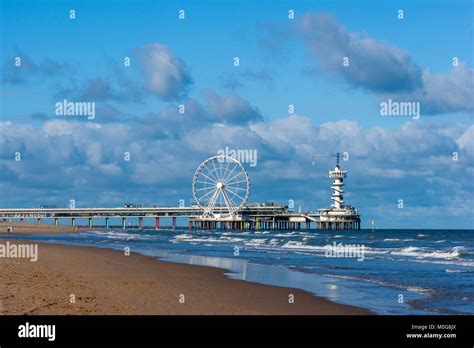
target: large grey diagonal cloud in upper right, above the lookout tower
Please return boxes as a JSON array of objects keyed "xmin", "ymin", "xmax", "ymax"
[{"xmin": 298, "ymin": 13, "xmax": 474, "ymax": 114}]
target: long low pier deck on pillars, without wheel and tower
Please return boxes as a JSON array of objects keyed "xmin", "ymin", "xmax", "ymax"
[{"xmin": 0, "ymin": 205, "xmax": 360, "ymax": 230}]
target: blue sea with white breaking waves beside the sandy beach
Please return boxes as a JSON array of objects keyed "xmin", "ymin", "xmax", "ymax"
[{"xmin": 4, "ymin": 229, "xmax": 474, "ymax": 315}]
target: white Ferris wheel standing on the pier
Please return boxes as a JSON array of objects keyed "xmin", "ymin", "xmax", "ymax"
[{"xmin": 193, "ymin": 156, "xmax": 250, "ymax": 218}]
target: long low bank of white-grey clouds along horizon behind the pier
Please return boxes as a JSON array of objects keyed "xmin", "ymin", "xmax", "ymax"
[{"xmin": 0, "ymin": 110, "xmax": 474, "ymax": 226}]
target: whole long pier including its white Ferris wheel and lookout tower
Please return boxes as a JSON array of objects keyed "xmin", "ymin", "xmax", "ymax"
[{"xmin": 0, "ymin": 153, "xmax": 360, "ymax": 230}]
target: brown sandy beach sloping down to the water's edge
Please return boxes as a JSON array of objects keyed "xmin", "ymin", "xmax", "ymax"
[{"xmin": 0, "ymin": 225, "xmax": 371, "ymax": 315}]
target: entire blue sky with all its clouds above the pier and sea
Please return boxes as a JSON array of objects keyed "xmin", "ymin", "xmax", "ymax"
[{"xmin": 0, "ymin": 0, "xmax": 474, "ymax": 228}]
